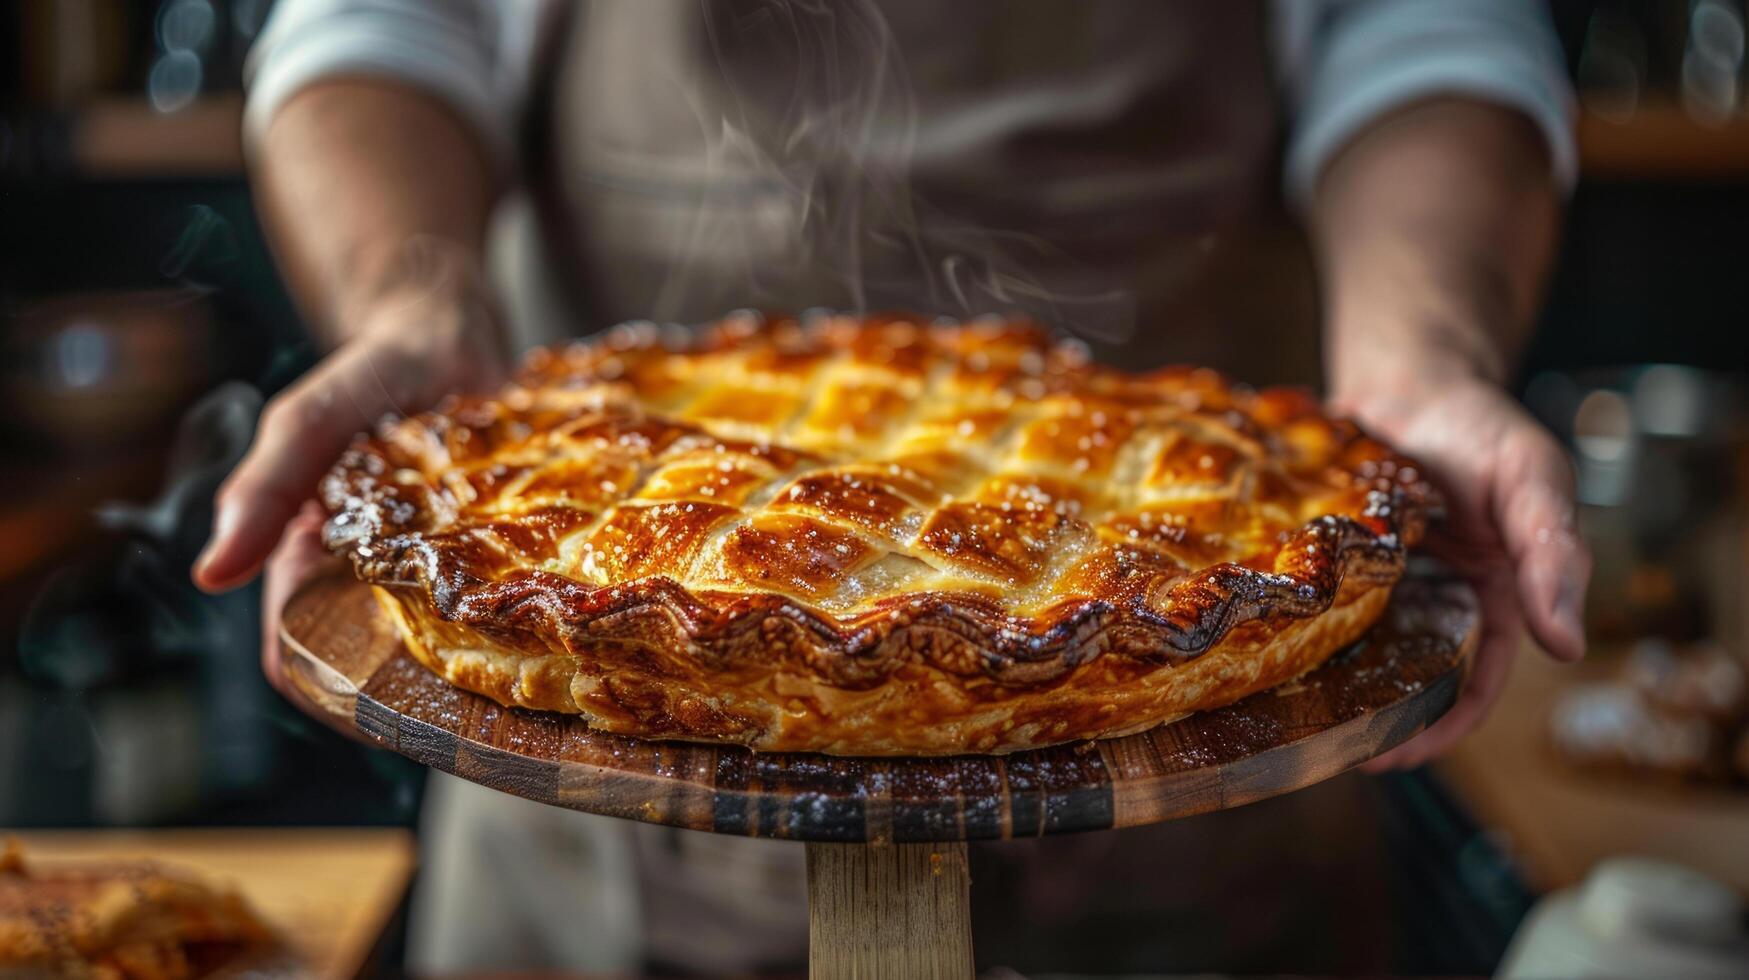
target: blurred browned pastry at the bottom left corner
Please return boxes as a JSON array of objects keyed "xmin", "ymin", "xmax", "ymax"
[{"xmin": 0, "ymin": 842, "xmax": 271, "ymax": 980}]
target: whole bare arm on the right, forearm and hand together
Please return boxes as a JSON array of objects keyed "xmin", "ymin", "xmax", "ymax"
[{"xmin": 1312, "ymin": 100, "xmax": 1590, "ymax": 767}]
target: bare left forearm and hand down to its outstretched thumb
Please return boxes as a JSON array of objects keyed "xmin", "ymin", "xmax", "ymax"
[{"xmin": 194, "ymin": 79, "xmax": 504, "ymax": 598}]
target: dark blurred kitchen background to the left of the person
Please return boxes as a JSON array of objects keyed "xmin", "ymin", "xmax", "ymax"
[{"xmin": 0, "ymin": 0, "xmax": 418, "ymax": 826}]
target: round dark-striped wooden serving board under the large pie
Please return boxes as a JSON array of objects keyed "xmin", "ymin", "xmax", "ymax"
[{"xmin": 282, "ymin": 572, "xmax": 1478, "ymax": 844}]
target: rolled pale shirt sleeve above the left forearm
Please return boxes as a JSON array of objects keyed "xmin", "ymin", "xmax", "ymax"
[{"xmin": 243, "ymin": 0, "xmax": 542, "ymax": 168}]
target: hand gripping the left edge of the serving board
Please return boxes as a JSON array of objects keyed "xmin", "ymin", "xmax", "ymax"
[{"xmin": 192, "ymin": 266, "xmax": 507, "ymax": 697}]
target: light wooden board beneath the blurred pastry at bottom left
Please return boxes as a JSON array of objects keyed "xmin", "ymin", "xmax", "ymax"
[{"xmin": 16, "ymin": 828, "xmax": 415, "ymax": 978}]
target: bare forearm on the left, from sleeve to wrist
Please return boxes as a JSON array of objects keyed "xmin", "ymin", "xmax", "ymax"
[{"xmin": 252, "ymin": 79, "xmax": 497, "ymax": 343}]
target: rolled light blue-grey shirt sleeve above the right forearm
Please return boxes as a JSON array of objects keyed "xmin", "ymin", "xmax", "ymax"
[{"xmin": 1273, "ymin": 0, "xmax": 1578, "ymax": 208}]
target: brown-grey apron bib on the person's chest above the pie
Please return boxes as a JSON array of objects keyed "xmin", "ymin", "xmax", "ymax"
[{"xmin": 530, "ymin": 0, "xmax": 1279, "ymax": 357}]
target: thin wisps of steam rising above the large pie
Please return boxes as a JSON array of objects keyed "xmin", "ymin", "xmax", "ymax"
[{"xmin": 656, "ymin": 0, "xmax": 1133, "ymax": 341}]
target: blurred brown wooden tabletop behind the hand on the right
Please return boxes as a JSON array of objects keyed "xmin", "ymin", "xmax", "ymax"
[{"xmin": 1438, "ymin": 649, "xmax": 1749, "ymax": 894}]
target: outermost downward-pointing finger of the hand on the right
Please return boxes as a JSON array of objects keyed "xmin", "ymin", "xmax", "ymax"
[{"xmin": 1492, "ymin": 418, "xmax": 1592, "ymax": 660}]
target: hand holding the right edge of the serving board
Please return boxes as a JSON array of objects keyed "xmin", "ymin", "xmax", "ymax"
[{"xmin": 1334, "ymin": 376, "xmax": 1592, "ymax": 772}]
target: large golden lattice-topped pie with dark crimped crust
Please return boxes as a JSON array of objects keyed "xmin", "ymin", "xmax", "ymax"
[{"xmin": 322, "ymin": 313, "xmax": 1431, "ymax": 756}]
